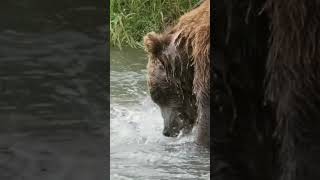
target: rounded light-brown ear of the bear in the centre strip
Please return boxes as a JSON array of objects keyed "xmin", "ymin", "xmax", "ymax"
[{"xmin": 143, "ymin": 32, "xmax": 163, "ymax": 57}]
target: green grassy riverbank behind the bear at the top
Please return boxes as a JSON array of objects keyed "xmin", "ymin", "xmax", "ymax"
[{"xmin": 110, "ymin": 0, "xmax": 199, "ymax": 48}]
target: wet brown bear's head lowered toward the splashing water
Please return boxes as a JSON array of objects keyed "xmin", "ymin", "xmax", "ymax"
[{"xmin": 144, "ymin": 32, "xmax": 197, "ymax": 137}]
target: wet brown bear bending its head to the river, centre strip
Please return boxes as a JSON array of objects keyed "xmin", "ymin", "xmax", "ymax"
[{"xmin": 144, "ymin": 0, "xmax": 210, "ymax": 146}]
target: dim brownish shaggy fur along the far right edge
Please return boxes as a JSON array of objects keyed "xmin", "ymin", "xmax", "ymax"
[{"xmin": 266, "ymin": 0, "xmax": 320, "ymax": 180}]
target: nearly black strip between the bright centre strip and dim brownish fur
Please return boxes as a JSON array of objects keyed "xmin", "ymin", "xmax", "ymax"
[{"xmin": 211, "ymin": 0, "xmax": 275, "ymax": 180}]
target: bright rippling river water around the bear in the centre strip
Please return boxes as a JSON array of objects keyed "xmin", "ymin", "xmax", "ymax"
[{"xmin": 110, "ymin": 49, "xmax": 210, "ymax": 180}]
